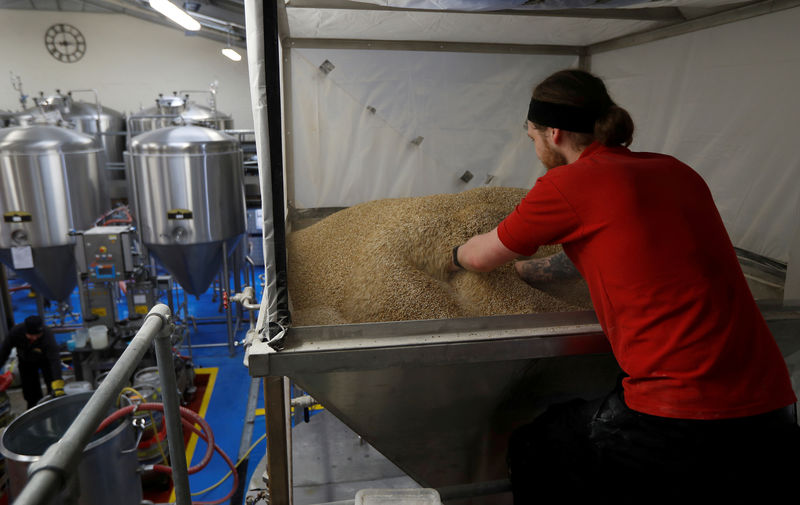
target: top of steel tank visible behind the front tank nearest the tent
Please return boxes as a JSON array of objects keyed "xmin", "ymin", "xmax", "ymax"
[{"xmin": 128, "ymin": 92, "xmax": 233, "ymax": 136}]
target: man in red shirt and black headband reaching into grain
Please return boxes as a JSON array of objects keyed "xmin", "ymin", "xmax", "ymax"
[{"xmin": 451, "ymin": 70, "xmax": 800, "ymax": 505}]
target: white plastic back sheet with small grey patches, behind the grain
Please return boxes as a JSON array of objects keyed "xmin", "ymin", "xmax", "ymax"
[{"xmin": 290, "ymin": 49, "xmax": 577, "ymax": 208}]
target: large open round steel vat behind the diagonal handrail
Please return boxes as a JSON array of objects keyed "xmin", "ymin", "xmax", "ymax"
[{"xmin": 0, "ymin": 393, "xmax": 142, "ymax": 505}]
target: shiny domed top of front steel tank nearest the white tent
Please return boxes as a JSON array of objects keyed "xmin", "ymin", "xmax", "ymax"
[{"xmin": 131, "ymin": 126, "xmax": 241, "ymax": 154}]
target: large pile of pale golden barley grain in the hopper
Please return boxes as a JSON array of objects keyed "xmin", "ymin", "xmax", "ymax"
[{"xmin": 287, "ymin": 188, "xmax": 591, "ymax": 326}]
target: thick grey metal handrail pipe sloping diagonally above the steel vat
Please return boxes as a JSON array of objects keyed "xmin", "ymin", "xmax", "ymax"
[{"xmin": 14, "ymin": 304, "xmax": 170, "ymax": 505}]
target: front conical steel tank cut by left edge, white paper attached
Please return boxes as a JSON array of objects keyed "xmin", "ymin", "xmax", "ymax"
[{"xmin": 0, "ymin": 126, "xmax": 108, "ymax": 301}]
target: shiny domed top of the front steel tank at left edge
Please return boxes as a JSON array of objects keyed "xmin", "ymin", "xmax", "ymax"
[{"xmin": 0, "ymin": 125, "xmax": 102, "ymax": 154}]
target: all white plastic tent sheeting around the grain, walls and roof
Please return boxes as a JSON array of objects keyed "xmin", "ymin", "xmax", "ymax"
[{"xmin": 287, "ymin": 0, "xmax": 800, "ymax": 261}]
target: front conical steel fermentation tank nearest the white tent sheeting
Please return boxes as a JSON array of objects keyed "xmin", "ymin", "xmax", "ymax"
[{"xmin": 127, "ymin": 126, "xmax": 245, "ymax": 295}]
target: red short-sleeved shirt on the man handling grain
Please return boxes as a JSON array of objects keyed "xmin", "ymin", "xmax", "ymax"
[{"xmin": 498, "ymin": 143, "xmax": 796, "ymax": 419}]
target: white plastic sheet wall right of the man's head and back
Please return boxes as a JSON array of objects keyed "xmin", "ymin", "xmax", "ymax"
[{"xmin": 592, "ymin": 9, "xmax": 800, "ymax": 261}]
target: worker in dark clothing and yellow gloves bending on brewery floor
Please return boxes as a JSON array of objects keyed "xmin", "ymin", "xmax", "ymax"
[{"xmin": 0, "ymin": 315, "xmax": 64, "ymax": 408}]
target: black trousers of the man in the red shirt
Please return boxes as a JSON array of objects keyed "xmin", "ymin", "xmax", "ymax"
[{"xmin": 508, "ymin": 387, "xmax": 800, "ymax": 505}]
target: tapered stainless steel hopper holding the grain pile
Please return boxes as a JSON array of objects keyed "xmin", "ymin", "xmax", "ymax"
[{"xmin": 246, "ymin": 305, "xmax": 800, "ymax": 504}]
